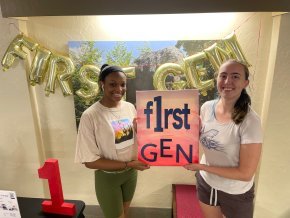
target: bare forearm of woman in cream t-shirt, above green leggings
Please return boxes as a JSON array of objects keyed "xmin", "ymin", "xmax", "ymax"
[{"xmin": 84, "ymin": 158, "xmax": 150, "ymax": 171}]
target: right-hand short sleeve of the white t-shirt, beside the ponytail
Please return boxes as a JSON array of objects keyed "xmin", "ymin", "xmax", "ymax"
[{"xmin": 240, "ymin": 111, "xmax": 263, "ymax": 144}]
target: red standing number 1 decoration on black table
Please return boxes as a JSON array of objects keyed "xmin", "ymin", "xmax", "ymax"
[{"xmin": 38, "ymin": 159, "xmax": 76, "ymax": 216}]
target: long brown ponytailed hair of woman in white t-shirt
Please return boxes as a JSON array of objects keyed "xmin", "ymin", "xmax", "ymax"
[{"xmin": 215, "ymin": 59, "xmax": 251, "ymax": 124}]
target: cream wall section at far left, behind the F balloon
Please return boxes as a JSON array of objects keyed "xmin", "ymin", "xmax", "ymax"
[{"xmin": 0, "ymin": 11, "xmax": 43, "ymax": 197}]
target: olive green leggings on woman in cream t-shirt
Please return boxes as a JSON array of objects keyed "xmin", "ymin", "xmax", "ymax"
[{"xmin": 95, "ymin": 169, "xmax": 137, "ymax": 218}]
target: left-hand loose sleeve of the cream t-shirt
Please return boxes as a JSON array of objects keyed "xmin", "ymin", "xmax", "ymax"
[{"xmin": 75, "ymin": 112, "xmax": 100, "ymax": 163}]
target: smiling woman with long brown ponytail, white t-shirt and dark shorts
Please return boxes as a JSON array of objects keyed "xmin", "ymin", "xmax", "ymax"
[{"xmin": 184, "ymin": 60, "xmax": 262, "ymax": 218}]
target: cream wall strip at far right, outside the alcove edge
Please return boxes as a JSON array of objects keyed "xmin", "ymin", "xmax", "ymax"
[{"xmin": 255, "ymin": 13, "xmax": 290, "ymax": 218}]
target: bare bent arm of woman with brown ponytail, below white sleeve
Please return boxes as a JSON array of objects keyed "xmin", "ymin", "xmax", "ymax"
[{"xmin": 184, "ymin": 143, "xmax": 262, "ymax": 181}]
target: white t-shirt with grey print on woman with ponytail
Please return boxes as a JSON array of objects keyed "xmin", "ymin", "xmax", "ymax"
[{"xmin": 200, "ymin": 100, "xmax": 263, "ymax": 194}]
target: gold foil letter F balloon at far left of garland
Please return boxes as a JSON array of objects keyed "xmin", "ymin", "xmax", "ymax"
[{"xmin": 1, "ymin": 34, "xmax": 38, "ymax": 71}]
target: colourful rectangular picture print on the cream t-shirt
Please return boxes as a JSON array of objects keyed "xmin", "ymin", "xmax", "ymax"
[{"xmin": 111, "ymin": 118, "xmax": 134, "ymax": 149}]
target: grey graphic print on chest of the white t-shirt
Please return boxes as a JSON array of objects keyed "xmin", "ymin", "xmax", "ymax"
[{"xmin": 200, "ymin": 127, "xmax": 224, "ymax": 152}]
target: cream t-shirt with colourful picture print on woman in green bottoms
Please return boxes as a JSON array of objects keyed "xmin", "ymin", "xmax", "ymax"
[{"xmin": 75, "ymin": 101, "xmax": 137, "ymax": 163}]
